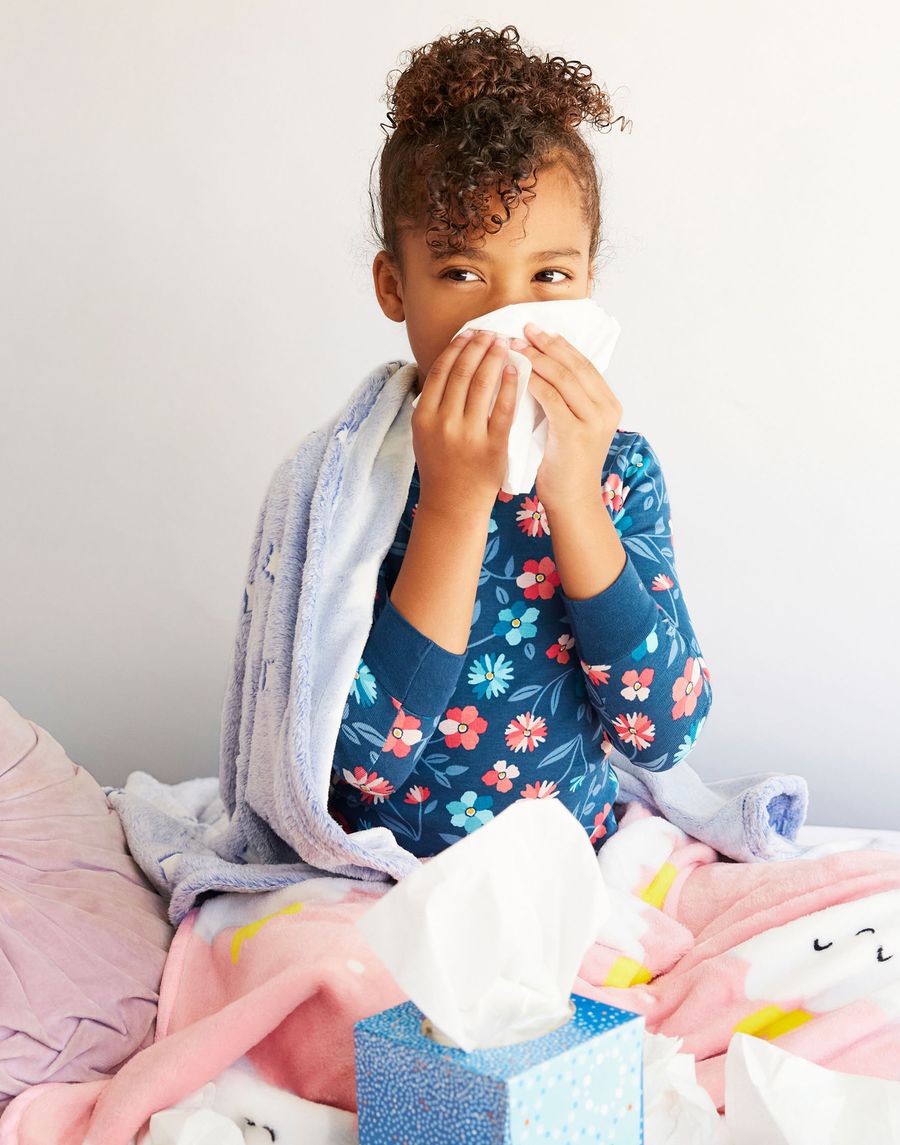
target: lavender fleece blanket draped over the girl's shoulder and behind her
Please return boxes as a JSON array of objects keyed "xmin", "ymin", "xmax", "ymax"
[{"xmin": 106, "ymin": 360, "xmax": 807, "ymax": 924}]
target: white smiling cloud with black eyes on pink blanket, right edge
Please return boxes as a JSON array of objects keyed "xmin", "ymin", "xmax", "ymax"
[{"xmin": 732, "ymin": 891, "xmax": 900, "ymax": 1037}]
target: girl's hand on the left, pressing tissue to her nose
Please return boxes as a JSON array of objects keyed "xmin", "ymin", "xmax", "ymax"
[{"xmin": 412, "ymin": 331, "xmax": 518, "ymax": 515}]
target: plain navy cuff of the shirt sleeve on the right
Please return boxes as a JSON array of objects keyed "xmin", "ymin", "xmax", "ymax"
[{"xmin": 560, "ymin": 553, "xmax": 660, "ymax": 664}]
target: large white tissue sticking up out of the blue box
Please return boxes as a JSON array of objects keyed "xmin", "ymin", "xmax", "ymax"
[{"xmin": 357, "ymin": 799, "xmax": 608, "ymax": 1051}]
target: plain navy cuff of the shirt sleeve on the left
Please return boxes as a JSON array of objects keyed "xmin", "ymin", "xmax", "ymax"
[{"xmin": 363, "ymin": 597, "xmax": 468, "ymax": 716}]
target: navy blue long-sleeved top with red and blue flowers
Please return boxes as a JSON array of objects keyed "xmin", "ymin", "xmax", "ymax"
[{"xmin": 329, "ymin": 429, "xmax": 712, "ymax": 856}]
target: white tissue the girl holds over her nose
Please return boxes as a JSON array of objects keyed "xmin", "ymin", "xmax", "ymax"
[{"xmin": 412, "ymin": 298, "xmax": 622, "ymax": 496}]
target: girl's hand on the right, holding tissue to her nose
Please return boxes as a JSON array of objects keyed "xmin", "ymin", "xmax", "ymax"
[{"xmin": 512, "ymin": 322, "xmax": 622, "ymax": 514}]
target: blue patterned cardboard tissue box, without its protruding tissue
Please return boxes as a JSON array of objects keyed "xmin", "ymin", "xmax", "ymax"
[{"xmin": 354, "ymin": 994, "xmax": 644, "ymax": 1145}]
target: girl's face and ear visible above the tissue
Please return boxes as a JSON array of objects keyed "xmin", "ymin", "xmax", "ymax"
[{"xmin": 372, "ymin": 165, "xmax": 593, "ymax": 393}]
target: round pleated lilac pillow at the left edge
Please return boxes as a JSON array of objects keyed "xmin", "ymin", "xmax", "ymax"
[{"xmin": 0, "ymin": 696, "xmax": 173, "ymax": 1111}]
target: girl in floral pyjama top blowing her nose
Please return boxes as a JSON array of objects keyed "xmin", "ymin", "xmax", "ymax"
[{"xmin": 329, "ymin": 25, "xmax": 711, "ymax": 856}]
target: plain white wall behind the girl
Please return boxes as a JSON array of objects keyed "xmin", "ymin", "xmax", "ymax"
[{"xmin": 0, "ymin": 0, "xmax": 900, "ymax": 827}]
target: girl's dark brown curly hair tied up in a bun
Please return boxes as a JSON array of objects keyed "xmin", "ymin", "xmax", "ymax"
[{"xmin": 369, "ymin": 24, "xmax": 631, "ymax": 275}]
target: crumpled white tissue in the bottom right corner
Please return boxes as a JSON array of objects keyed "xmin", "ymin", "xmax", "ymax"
[{"xmin": 725, "ymin": 1034, "xmax": 900, "ymax": 1145}]
